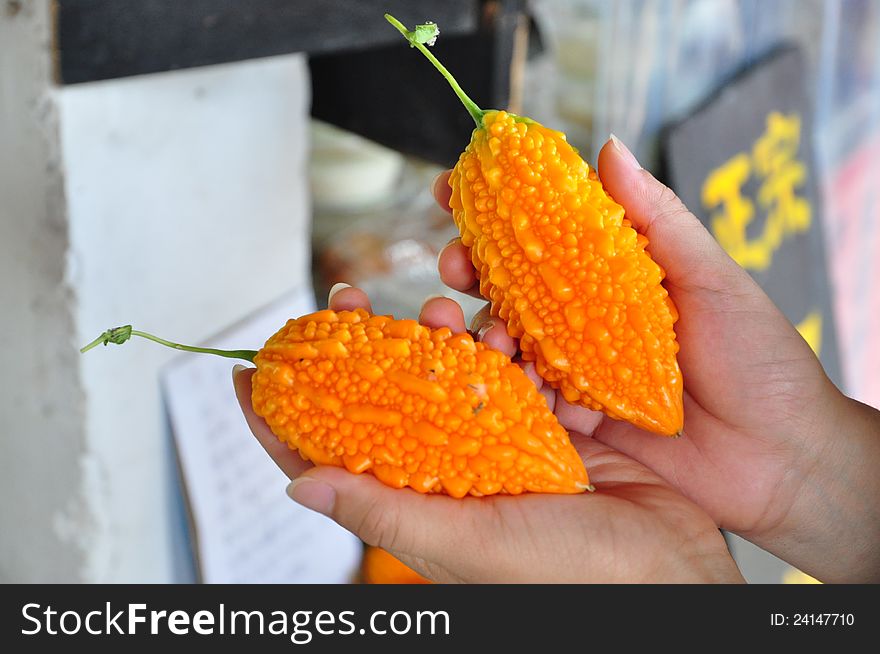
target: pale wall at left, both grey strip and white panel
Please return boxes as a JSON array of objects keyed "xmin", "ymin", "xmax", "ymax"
[{"xmin": 0, "ymin": 3, "xmax": 309, "ymax": 582}]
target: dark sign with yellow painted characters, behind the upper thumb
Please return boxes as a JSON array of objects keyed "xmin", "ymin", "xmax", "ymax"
[{"xmin": 664, "ymin": 48, "xmax": 841, "ymax": 383}]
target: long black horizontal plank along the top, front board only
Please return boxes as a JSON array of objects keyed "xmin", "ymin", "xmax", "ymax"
[{"xmin": 55, "ymin": 0, "xmax": 481, "ymax": 84}]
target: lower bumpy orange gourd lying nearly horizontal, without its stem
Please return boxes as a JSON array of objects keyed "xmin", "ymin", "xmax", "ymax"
[{"xmin": 252, "ymin": 309, "xmax": 589, "ymax": 497}]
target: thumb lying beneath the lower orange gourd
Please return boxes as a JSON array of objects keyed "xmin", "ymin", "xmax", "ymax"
[{"xmin": 287, "ymin": 466, "xmax": 464, "ymax": 579}]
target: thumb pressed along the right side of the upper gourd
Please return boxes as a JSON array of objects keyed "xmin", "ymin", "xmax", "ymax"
[{"xmin": 599, "ymin": 136, "xmax": 755, "ymax": 294}]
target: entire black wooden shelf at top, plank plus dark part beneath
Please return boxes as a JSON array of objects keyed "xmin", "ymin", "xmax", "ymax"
[{"xmin": 54, "ymin": 0, "xmax": 524, "ymax": 164}]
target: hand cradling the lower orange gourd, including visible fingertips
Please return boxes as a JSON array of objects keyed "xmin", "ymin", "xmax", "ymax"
[{"xmin": 233, "ymin": 287, "xmax": 742, "ymax": 583}]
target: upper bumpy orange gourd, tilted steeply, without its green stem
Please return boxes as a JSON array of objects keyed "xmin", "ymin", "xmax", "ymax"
[{"xmin": 450, "ymin": 111, "xmax": 683, "ymax": 435}]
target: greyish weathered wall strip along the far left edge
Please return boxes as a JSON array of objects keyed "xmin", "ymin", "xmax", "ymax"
[{"xmin": 0, "ymin": 2, "xmax": 94, "ymax": 581}]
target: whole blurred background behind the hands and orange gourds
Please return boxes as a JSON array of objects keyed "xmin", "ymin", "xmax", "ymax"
[{"xmin": 0, "ymin": 0, "xmax": 880, "ymax": 583}]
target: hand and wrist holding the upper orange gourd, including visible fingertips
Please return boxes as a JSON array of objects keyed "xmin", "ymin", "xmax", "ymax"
[{"xmin": 434, "ymin": 137, "xmax": 880, "ymax": 582}]
